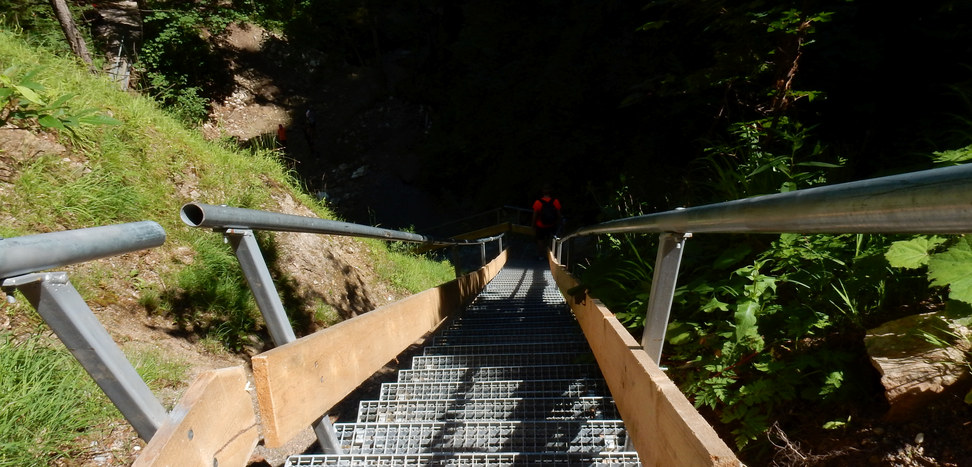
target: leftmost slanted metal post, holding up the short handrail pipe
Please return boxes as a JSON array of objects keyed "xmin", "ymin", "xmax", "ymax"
[{"xmin": 3, "ymin": 272, "xmax": 168, "ymax": 441}]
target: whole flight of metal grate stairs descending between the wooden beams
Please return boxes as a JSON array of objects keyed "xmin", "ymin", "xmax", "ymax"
[{"xmin": 286, "ymin": 262, "xmax": 641, "ymax": 466}]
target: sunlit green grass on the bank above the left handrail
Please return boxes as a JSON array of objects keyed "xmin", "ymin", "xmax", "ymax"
[{"xmin": 0, "ymin": 27, "xmax": 312, "ymax": 241}]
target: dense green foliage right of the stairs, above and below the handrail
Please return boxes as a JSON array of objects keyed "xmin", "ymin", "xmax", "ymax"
[{"xmin": 568, "ymin": 1, "xmax": 972, "ymax": 460}]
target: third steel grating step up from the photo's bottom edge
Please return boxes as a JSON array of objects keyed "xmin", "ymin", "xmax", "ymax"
[{"xmin": 357, "ymin": 397, "xmax": 620, "ymax": 423}]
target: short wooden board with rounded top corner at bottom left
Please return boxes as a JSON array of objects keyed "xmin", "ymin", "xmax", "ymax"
[{"xmin": 132, "ymin": 367, "xmax": 259, "ymax": 467}]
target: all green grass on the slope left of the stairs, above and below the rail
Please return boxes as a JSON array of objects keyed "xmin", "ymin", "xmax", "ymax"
[{"xmin": 0, "ymin": 25, "xmax": 453, "ymax": 466}]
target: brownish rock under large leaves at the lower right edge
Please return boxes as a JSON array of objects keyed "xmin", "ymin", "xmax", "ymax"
[{"xmin": 864, "ymin": 313, "xmax": 970, "ymax": 421}]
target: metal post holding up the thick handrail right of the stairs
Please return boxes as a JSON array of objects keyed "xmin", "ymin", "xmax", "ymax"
[{"xmin": 641, "ymin": 233, "xmax": 692, "ymax": 363}]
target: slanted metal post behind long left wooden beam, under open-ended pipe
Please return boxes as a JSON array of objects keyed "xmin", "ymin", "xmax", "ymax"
[{"xmin": 224, "ymin": 229, "xmax": 343, "ymax": 454}]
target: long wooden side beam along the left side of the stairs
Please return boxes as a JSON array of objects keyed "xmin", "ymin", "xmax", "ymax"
[{"xmin": 251, "ymin": 252, "xmax": 507, "ymax": 448}]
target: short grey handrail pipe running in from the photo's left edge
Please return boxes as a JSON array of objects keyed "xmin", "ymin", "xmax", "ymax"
[{"xmin": 0, "ymin": 221, "xmax": 165, "ymax": 279}]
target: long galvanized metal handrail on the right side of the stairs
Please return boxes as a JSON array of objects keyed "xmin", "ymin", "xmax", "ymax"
[{"xmin": 563, "ymin": 164, "xmax": 972, "ymax": 240}]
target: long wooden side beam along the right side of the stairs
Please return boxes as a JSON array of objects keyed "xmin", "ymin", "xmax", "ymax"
[{"xmin": 549, "ymin": 256, "xmax": 741, "ymax": 466}]
